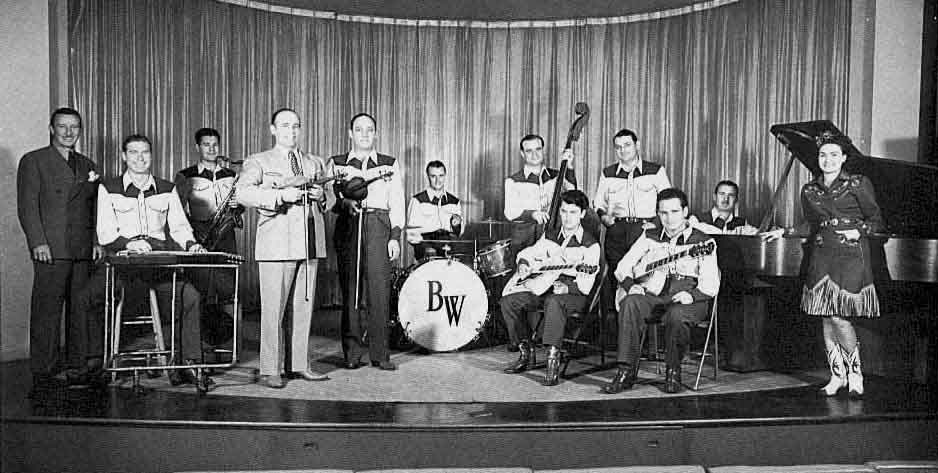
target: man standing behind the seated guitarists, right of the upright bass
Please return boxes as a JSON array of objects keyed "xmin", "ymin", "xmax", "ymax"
[{"xmin": 593, "ymin": 129, "xmax": 671, "ymax": 267}]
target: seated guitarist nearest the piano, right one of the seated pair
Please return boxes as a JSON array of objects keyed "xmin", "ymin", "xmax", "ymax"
[{"xmin": 603, "ymin": 188, "xmax": 720, "ymax": 394}]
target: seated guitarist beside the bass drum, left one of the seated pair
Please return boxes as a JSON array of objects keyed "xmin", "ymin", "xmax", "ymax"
[{"xmin": 499, "ymin": 190, "xmax": 600, "ymax": 386}]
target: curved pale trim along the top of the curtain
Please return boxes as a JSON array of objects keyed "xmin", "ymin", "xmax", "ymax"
[{"xmin": 216, "ymin": 0, "xmax": 739, "ymax": 29}]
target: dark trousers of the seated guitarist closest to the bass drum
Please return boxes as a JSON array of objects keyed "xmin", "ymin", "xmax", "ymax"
[{"xmin": 498, "ymin": 292, "xmax": 587, "ymax": 347}]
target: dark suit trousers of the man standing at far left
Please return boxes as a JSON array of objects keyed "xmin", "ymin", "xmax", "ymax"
[{"xmin": 29, "ymin": 259, "xmax": 91, "ymax": 375}]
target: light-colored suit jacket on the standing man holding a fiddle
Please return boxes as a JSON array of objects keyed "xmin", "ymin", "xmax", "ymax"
[{"xmin": 235, "ymin": 148, "xmax": 334, "ymax": 261}]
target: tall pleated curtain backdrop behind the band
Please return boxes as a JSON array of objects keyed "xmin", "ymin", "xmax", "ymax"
[{"xmin": 69, "ymin": 0, "xmax": 850, "ymax": 306}]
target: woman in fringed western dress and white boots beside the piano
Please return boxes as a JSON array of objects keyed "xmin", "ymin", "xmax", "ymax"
[{"xmin": 767, "ymin": 132, "xmax": 883, "ymax": 396}]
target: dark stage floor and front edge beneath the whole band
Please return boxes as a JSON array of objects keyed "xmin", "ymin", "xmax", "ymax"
[{"xmin": 2, "ymin": 312, "xmax": 938, "ymax": 472}]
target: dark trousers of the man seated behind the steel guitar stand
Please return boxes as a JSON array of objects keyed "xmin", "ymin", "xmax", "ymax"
[{"xmin": 76, "ymin": 267, "xmax": 202, "ymax": 362}]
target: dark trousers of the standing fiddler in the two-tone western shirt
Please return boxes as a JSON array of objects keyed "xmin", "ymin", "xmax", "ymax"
[{"xmin": 335, "ymin": 212, "xmax": 391, "ymax": 362}]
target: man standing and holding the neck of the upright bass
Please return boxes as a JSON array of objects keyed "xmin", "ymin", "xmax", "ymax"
[{"xmin": 505, "ymin": 135, "xmax": 576, "ymax": 254}]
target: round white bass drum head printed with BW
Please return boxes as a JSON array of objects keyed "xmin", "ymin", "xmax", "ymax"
[{"xmin": 397, "ymin": 259, "xmax": 488, "ymax": 351}]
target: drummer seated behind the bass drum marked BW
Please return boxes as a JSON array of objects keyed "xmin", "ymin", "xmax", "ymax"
[{"xmin": 407, "ymin": 161, "xmax": 462, "ymax": 260}]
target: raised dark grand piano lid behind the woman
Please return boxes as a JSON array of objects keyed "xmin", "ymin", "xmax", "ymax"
[{"xmin": 769, "ymin": 120, "xmax": 938, "ymax": 238}]
